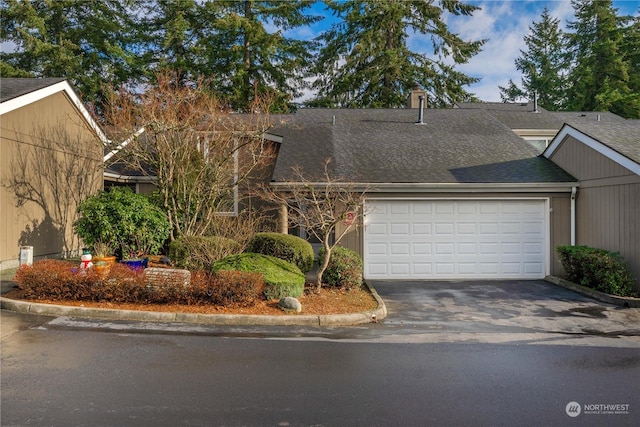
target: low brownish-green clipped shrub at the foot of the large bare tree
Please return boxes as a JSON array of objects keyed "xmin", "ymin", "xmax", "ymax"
[{"xmin": 169, "ymin": 236, "xmax": 241, "ymax": 270}]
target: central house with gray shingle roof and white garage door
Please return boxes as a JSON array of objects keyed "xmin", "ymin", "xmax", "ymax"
[{"xmin": 270, "ymin": 98, "xmax": 579, "ymax": 279}]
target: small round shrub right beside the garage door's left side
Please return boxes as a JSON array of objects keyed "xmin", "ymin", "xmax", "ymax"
[{"xmin": 319, "ymin": 246, "xmax": 362, "ymax": 289}]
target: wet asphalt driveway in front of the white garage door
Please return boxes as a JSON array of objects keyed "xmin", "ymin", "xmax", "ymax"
[{"xmin": 370, "ymin": 280, "xmax": 640, "ymax": 339}]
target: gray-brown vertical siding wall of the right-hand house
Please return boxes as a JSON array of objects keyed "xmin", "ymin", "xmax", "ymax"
[{"xmin": 551, "ymin": 136, "xmax": 640, "ymax": 288}]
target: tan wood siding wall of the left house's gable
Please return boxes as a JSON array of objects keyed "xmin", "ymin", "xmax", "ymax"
[{"xmin": 0, "ymin": 92, "xmax": 102, "ymax": 268}]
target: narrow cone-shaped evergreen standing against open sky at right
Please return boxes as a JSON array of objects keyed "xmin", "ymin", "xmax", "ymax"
[{"xmin": 500, "ymin": 7, "xmax": 566, "ymax": 111}]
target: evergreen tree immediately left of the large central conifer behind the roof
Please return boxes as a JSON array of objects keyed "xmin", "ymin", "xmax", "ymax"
[{"xmin": 206, "ymin": 0, "xmax": 320, "ymax": 112}]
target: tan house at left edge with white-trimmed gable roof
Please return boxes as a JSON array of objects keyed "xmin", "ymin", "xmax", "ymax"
[{"xmin": 0, "ymin": 78, "xmax": 106, "ymax": 269}]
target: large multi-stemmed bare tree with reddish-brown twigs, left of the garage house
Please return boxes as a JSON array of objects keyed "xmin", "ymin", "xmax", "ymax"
[{"xmin": 105, "ymin": 72, "xmax": 271, "ymax": 240}]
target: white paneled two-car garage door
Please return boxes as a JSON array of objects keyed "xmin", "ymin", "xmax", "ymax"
[{"xmin": 364, "ymin": 200, "xmax": 548, "ymax": 279}]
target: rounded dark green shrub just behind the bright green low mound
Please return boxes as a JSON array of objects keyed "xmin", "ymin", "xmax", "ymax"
[{"xmin": 246, "ymin": 233, "xmax": 314, "ymax": 273}]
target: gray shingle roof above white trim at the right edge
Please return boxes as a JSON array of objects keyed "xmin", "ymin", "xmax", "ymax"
[{"xmin": 570, "ymin": 122, "xmax": 640, "ymax": 164}]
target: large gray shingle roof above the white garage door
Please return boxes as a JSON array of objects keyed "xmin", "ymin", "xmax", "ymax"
[{"xmin": 270, "ymin": 109, "xmax": 575, "ymax": 183}]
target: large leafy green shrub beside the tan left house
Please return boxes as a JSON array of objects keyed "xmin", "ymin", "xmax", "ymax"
[{"xmin": 73, "ymin": 187, "xmax": 171, "ymax": 257}]
